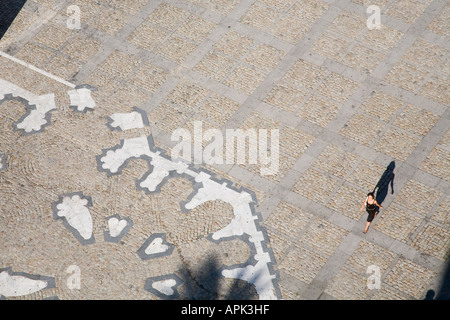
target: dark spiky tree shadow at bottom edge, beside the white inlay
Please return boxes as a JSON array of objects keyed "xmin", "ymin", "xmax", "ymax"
[{"xmin": 179, "ymin": 255, "xmax": 259, "ymax": 300}]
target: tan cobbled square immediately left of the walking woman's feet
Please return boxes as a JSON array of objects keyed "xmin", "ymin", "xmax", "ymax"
[{"xmin": 298, "ymin": 218, "xmax": 348, "ymax": 256}]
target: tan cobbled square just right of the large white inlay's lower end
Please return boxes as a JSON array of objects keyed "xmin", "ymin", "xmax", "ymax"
[{"xmin": 279, "ymin": 245, "xmax": 327, "ymax": 284}]
